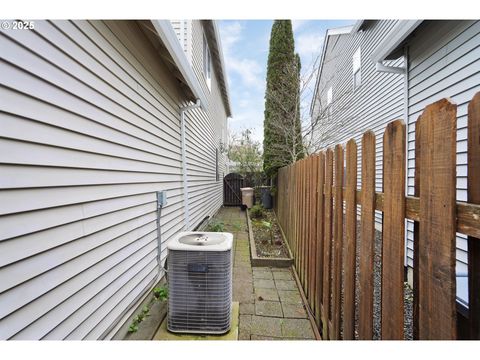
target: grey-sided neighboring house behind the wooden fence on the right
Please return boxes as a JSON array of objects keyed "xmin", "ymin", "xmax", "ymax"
[{"xmin": 311, "ymin": 20, "xmax": 480, "ymax": 305}]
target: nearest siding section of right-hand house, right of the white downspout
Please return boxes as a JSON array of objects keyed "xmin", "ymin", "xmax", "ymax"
[{"xmin": 407, "ymin": 21, "xmax": 480, "ymax": 273}]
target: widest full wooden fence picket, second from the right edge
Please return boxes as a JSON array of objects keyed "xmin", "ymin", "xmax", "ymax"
[{"xmin": 414, "ymin": 99, "xmax": 457, "ymax": 340}]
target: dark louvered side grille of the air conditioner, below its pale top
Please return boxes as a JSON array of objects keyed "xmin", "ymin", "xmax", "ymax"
[{"xmin": 168, "ymin": 250, "xmax": 232, "ymax": 333}]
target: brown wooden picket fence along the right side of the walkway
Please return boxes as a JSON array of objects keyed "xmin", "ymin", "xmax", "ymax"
[{"xmin": 276, "ymin": 93, "xmax": 480, "ymax": 339}]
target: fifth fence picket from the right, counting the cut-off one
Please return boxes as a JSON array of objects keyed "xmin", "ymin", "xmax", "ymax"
[{"xmin": 343, "ymin": 139, "xmax": 357, "ymax": 340}]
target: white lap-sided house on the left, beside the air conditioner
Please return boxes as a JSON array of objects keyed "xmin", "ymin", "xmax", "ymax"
[{"xmin": 0, "ymin": 21, "xmax": 230, "ymax": 339}]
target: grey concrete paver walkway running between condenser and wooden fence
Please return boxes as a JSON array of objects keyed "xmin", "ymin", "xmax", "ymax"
[{"xmin": 216, "ymin": 208, "xmax": 315, "ymax": 340}]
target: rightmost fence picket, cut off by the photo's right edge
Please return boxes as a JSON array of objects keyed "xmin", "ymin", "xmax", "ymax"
[{"xmin": 467, "ymin": 92, "xmax": 480, "ymax": 339}]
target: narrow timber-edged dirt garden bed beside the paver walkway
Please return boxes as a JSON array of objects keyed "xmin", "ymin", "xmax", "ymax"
[{"xmin": 247, "ymin": 208, "xmax": 293, "ymax": 267}]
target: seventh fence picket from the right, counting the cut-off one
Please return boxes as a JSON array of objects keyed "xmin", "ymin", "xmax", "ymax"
[{"xmin": 322, "ymin": 149, "xmax": 333, "ymax": 340}]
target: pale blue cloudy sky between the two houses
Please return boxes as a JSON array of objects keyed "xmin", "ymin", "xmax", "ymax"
[{"xmin": 218, "ymin": 20, "xmax": 354, "ymax": 142}]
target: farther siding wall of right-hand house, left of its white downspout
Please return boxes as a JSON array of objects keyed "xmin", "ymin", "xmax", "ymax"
[{"xmin": 312, "ymin": 20, "xmax": 404, "ymax": 228}]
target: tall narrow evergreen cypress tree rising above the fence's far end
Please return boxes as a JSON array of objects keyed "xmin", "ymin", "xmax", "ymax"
[{"xmin": 263, "ymin": 20, "xmax": 303, "ymax": 177}]
